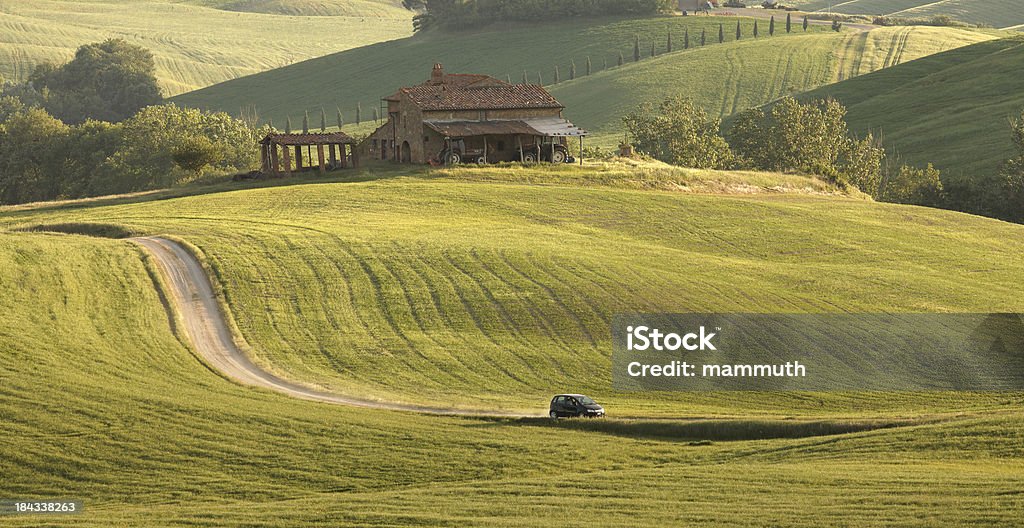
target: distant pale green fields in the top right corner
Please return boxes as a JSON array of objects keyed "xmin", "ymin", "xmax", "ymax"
[{"xmin": 787, "ymin": 0, "xmax": 1024, "ymax": 28}]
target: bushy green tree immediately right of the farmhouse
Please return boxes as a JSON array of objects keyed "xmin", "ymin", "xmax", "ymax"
[{"xmin": 623, "ymin": 97, "xmax": 732, "ymax": 169}]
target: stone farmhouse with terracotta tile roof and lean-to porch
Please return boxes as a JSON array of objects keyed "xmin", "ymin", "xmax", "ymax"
[{"xmin": 358, "ymin": 64, "xmax": 587, "ymax": 164}]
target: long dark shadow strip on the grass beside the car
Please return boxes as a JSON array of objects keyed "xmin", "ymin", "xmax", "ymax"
[{"xmin": 477, "ymin": 419, "xmax": 923, "ymax": 445}]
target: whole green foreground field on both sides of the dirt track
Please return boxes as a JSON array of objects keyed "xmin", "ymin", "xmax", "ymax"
[{"xmin": 0, "ymin": 165, "xmax": 1024, "ymax": 527}]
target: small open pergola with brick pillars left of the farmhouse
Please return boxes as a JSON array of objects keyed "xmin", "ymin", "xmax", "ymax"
[{"xmin": 260, "ymin": 132, "xmax": 356, "ymax": 176}]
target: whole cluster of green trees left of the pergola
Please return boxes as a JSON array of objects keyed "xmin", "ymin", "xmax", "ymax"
[{"xmin": 0, "ymin": 40, "xmax": 269, "ymax": 204}]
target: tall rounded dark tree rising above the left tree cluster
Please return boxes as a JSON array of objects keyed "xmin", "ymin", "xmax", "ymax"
[{"xmin": 29, "ymin": 39, "xmax": 162, "ymax": 124}]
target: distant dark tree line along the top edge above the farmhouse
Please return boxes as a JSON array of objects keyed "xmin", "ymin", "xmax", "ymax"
[{"xmin": 402, "ymin": 0, "xmax": 676, "ymax": 31}]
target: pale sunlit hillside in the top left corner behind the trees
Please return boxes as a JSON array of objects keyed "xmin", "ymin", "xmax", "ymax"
[{"xmin": 0, "ymin": 0, "xmax": 413, "ymax": 96}]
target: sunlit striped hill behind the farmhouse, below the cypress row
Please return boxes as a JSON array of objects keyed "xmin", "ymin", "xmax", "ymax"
[{"xmin": 552, "ymin": 28, "xmax": 992, "ymax": 142}]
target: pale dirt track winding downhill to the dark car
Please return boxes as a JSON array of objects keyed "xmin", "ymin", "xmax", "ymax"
[{"xmin": 130, "ymin": 236, "xmax": 544, "ymax": 417}]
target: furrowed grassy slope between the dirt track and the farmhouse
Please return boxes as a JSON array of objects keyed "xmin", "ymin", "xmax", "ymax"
[{"xmin": 4, "ymin": 160, "xmax": 1024, "ymax": 415}]
